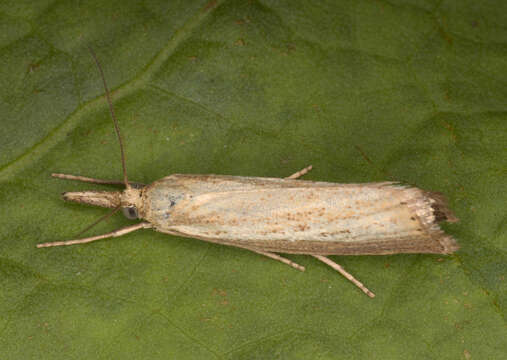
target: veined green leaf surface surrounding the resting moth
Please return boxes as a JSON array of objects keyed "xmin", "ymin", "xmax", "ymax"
[{"xmin": 0, "ymin": 0, "xmax": 507, "ymax": 359}]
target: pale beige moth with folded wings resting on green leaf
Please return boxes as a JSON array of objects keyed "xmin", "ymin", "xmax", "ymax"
[{"xmin": 37, "ymin": 49, "xmax": 459, "ymax": 297}]
